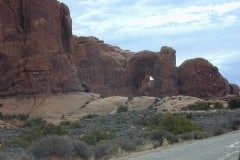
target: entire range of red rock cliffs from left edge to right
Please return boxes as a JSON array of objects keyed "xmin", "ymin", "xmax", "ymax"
[{"xmin": 0, "ymin": 0, "xmax": 239, "ymax": 97}]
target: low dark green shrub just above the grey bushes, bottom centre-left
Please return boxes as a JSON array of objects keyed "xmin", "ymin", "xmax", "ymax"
[{"xmin": 80, "ymin": 131, "xmax": 115, "ymax": 145}]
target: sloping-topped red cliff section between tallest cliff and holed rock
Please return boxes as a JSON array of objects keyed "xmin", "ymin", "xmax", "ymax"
[{"xmin": 72, "ymin": 37, "xmax": 131, "ymax": 96}]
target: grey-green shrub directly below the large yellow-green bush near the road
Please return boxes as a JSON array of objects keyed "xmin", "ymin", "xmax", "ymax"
[{"xmin": 147, "ymin": 129, "xmax": 178, "ymax": 144}]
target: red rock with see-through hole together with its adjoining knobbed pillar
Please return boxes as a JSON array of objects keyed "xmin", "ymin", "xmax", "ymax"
[{"xmin": 124, "ymin": 46, "xmax": 178, "ymax": 97}]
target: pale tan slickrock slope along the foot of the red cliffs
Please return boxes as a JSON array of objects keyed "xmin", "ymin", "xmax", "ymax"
[{"xmin": 0, "ymin": 92, "xmax": 224, "ymax": 126}]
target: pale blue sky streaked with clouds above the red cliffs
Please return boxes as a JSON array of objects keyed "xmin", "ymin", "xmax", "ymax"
[{"xmin": 60, "ymin": 0, "xmax": 240, "ymax": 85}]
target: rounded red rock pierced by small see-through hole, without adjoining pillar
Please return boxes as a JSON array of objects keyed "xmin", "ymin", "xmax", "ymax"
[{"xmin": 126, "ymin": 51, "xmax": 161, "ymax": 96}]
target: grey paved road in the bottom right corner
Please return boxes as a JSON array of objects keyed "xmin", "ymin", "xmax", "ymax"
[{"xmin": 118, "ymin": 131, "xmax": 240, "ymax": 160}]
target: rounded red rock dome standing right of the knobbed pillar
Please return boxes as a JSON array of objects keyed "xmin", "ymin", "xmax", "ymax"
[{"xmin": 178, "ymin": 58, "xmax": 228, "ymax": 97}]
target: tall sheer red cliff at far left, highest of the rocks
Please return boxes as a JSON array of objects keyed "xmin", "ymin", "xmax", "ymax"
[{"xmin": 0, "ymin": 0, "xmax": 83, "ymax": 96}]
